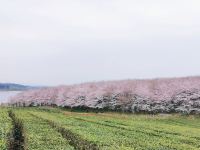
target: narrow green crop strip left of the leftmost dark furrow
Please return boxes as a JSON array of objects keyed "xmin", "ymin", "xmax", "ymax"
[{"xmin": 0, "ymin": 108, "xmax": 12, "ymax": 150}]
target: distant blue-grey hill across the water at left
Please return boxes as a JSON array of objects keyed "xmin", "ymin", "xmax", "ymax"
[{"xmin": 0, "ymin": 83, "xmax": 34, "ymax": 91}]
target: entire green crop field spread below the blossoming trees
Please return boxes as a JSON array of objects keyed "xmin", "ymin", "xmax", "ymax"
[{"xmin": 0, "ymin": 107, "xmax": 200, "ymax": 150}]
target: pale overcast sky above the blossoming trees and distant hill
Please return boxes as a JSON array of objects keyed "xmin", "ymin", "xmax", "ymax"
[{"xmin": 0, "ymin": 0, "xmax": 200, "ymax": 85}]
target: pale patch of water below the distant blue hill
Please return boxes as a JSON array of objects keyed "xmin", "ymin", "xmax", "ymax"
[{"xmin": 0, "ymin": 91, "xmax": 21, "ymax": 104}]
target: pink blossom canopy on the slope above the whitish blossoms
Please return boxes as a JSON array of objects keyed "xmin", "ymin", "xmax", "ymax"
[{"xmin": 10, "ymin": 77, "xmax": 200, "ymax": 105}]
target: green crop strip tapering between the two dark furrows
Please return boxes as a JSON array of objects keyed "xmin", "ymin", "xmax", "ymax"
[{"xmin": 14, "ymin": 110, "xmax": 73, "ymax": 150}]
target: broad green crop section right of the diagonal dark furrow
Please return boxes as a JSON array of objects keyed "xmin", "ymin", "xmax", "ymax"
[{"xmin": 30, "ymin": 110, "xmax": 200, "ymax": 150}]
